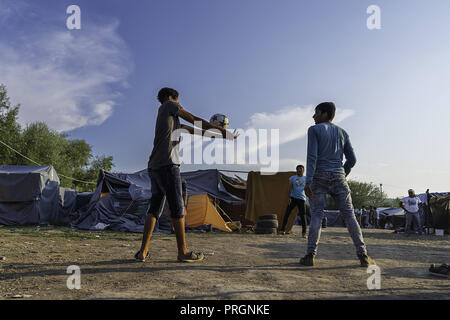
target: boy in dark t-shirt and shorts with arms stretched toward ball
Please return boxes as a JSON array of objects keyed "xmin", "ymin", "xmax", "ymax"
[{"xmin": 135, "ymin": 88, "xmax": 238, "ymax": 262}]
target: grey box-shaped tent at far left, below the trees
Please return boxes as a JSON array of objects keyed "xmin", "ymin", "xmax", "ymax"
[{"xmin": 0, "ymin": 166, "xmax": 62, "ymax": 225}]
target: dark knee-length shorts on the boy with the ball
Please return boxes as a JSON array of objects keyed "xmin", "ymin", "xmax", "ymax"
[{"xmin": 147, "ymin": 165, "xmax": 184, "ymax": 219}]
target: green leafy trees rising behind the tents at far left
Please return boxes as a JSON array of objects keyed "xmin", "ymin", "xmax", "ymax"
[{"xmin": 0, "ymin": 85, "xmax": 114, "ymax": 191}]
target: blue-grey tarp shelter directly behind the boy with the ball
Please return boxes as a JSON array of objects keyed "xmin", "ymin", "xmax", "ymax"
[{"xmin": 72, "ymin": 169, "xmax": 244, "ymax": 233}]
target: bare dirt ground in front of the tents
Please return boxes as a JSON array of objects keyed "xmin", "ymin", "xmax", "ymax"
[{"xmin": 0, "ymin": 226, "xmax": 450, "ymax": 300}]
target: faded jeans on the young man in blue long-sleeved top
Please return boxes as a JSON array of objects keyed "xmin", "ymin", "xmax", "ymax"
[{"xmin": 307, "ymin": 171, "xmax": 367, "ymax": 255}]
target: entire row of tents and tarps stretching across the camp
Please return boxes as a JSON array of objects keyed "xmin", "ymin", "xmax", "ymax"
[{"xmin": 0, "ymin": 166, "xmax": 450, "ymax": 232}]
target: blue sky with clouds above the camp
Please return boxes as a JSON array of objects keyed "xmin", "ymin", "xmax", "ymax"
[{"xmin": 0, "ymin": 0, "xmax": 450, "ymax": 197}]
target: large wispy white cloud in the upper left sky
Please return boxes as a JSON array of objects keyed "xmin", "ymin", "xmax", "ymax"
[{"xmin": 0, "ymin": 15, "xmax": 132, "ymax": 131}]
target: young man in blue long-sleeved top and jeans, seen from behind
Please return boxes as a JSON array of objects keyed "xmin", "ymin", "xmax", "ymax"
[{"xmin": 300, "ymin": 102, "xmax": 375, "ymax": 267}]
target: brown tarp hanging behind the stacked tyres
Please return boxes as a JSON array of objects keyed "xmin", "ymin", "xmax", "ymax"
[{"xmin": 245, "ymin": 171, "xmax": 298, "ymax": 231}]
